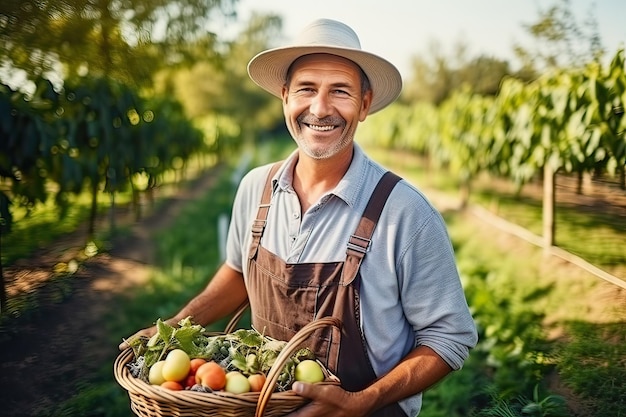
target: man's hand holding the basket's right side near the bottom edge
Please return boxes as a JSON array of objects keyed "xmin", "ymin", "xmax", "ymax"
[{"xmin": 287, "ymin": 382, "xmax": 373, "ymax": 417}]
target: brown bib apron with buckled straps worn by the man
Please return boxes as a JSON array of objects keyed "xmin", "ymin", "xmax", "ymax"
[{"xmin": 243, "ymin": 163, "xmax": 406, "ymax": 417}]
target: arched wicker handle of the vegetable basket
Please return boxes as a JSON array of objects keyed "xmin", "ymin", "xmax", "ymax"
[{"xmin": 255, "ymin": 316, "xmax": 341, "ymax": 417}]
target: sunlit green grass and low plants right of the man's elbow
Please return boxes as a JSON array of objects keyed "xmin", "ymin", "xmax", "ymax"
[{"xmin": 414, "ymin": 213, "xmax": 626, "ymax": 417}]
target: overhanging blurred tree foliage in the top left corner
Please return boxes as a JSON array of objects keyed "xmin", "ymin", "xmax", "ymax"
[{"xmin": 0, "ymin": 0, "xmax": 237, "ymax": 86}]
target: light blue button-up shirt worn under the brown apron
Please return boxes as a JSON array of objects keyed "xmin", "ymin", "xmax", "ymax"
[{"xmin": 226, "ymin": 143, "xmax": 477, "ymax": 416}]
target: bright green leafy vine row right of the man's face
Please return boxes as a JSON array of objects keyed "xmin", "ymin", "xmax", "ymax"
[{"xmin": 363, "ymin": 50, "xmax": 626, "ymax": 196}]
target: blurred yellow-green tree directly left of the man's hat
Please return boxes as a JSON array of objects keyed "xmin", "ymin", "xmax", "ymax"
[{"xmin": 155, "ymin": 14, "xmax": 282, "ymax": 152}]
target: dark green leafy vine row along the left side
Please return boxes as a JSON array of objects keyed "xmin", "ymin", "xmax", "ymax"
[{"xmin": 0, "ymin": 78, "xmax": 205, "ymax": 309}]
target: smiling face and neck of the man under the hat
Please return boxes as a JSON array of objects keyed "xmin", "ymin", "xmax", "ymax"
[{"xmin": 281, "ymin": 54, "xmax": 372, "ymax": 212}]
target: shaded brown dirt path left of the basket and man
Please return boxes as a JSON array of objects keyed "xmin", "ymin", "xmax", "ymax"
[{"xmin": 0, "ymin": 167, "xmax": 223, "ymax": 417}]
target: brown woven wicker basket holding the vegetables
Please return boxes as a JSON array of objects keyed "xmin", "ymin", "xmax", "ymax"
[{"xmin": 113, "ymin": 317, "xmax": 340, "ymax": 417}]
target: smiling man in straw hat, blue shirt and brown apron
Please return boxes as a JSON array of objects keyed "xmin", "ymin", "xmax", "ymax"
[{"xmin": 120, "ymin": 19, "xmax": 477, "ymax": 417}]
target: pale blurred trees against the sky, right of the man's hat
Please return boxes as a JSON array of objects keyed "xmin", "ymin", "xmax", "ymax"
[{"xmin": 402, "ymin": 0, "xmax": 605, "ymax": 105}]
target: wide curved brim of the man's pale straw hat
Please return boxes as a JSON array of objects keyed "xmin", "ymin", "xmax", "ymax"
[{"xmin": 248, "ymin": 45, "xmax": 402, "ymax": 114}]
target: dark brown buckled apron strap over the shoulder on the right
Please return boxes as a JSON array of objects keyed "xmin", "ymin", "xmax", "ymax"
[{"xmin": 341, "ymin": 171, "xmax": 401, "ymax": 285}]
